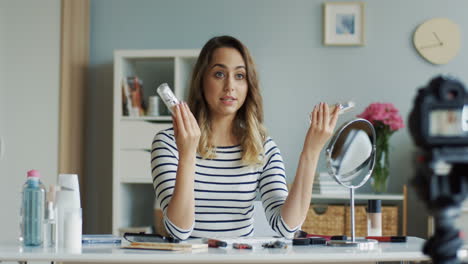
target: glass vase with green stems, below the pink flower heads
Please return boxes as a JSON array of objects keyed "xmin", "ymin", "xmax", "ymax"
[{"xmin": 371, "ymin": 135, "xmax": 390, "ymax": 193}]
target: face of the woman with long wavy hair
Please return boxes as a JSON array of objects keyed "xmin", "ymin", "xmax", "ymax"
[{"xmin": 203, "ymin": 47, "xmax": 248, "ymax": 117}]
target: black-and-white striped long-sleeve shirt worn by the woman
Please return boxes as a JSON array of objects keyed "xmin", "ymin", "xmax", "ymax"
[{"xmin": 151, "ymin": 128, "xmax": 298, "ymax": 239}]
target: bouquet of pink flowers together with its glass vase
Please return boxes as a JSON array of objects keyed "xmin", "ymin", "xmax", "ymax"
[{"xmin": 358, "ymin": 103, "xmax": 404, "ymax": 193}]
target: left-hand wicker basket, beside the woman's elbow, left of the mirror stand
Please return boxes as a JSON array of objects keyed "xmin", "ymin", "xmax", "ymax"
[{"xmin": 302, "ymin": 205, "xmax": 345, "ymax": 235}]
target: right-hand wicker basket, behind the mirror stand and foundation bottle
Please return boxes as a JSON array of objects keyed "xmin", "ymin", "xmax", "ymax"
[{"xmin": 345, "ymin": 205, "xmax": 398, "ymax": 237}]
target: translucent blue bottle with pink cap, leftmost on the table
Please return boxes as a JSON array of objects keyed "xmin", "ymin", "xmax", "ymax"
[{"xmin": 21, "ymin": 170, "xmax": 45, "ymax": 246}]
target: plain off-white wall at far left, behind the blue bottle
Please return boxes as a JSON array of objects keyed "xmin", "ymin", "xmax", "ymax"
[{"xmin": 0, "ymin": 0, "xmax": 60, "ymax": 241}]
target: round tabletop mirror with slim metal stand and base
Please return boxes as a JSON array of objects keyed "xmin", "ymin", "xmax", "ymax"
[{"xmin": 326, "ymin": 119, "xmax": 377, "ymax": 249}]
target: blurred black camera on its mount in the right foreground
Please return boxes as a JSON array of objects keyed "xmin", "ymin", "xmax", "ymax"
[{"xmin": 409, "ymin": 76, "xmax": 468, "ymax": 263}]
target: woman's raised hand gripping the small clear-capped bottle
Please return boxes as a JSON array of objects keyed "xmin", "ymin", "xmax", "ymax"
[{"xmin": 172, "ymin": 102, "xmax": 200, "ymax": 156}]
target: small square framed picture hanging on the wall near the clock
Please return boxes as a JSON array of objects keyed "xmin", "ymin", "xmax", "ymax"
[{"xmin": 323, "ymin": 2, "xmax": 365, "ymax": 46}]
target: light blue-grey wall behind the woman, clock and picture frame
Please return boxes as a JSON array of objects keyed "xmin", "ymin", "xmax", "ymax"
[{"xmin": 87, "ymin": 0, "xmax": 468, "ymax": 235}]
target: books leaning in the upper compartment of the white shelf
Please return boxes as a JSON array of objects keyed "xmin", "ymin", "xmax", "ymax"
[{"xmin": 122, "ymin": 76, "xmax": 146, "ymax": 117}]
